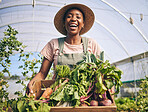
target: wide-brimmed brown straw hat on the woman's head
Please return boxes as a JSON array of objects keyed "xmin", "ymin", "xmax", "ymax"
[{"xmin": 54, "ymin": 4, "xmax": 95, "ymax": 35}]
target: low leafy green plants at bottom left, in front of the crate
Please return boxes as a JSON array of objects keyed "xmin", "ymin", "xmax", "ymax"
[{"xmin": 8, "ymin": 96, "xmax": 50, "ymax": 112}]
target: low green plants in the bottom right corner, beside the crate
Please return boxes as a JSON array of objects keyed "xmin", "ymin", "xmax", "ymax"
[{"xmin": 115, "ymin": 77, "xmax": 148, "ymax": 112}]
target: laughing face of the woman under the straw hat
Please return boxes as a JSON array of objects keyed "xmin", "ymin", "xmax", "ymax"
[{"xmin": 65, "ymin": 9, "xmax": 84, "ymax": 35}]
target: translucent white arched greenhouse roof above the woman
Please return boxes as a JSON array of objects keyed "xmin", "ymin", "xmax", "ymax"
[{"xmin": 0, "ymin": 0, "xmax": 148, "ymax": 63}]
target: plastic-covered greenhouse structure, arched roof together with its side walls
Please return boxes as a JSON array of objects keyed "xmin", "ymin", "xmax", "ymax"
[{"xmin": 0, "ymin": 0, "xmax": 148, "ymax": 111}]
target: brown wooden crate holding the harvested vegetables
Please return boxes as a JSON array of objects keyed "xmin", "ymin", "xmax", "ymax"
[{"xmin": 33, "ymin": 80, "xmax": 117, "ymax": 112}]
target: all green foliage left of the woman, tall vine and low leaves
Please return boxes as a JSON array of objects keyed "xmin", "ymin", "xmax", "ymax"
[{"xmin": 0, "ymin": 26, "xmax": 50, "ymax": 112}]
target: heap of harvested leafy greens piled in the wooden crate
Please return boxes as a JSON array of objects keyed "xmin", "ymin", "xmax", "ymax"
[{"xmin": 49, "ymin": 54, "xmax": 122, "ymax": 107}]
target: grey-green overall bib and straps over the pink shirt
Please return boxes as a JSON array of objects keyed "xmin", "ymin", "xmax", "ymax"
[{"xmin": 57, "ymin": 37, "xmax": 88, "ymax": 68}]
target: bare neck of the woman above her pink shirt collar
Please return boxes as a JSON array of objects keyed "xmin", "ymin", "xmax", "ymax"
[{"xmin": 65, "ymin": 35, "xmax": 82, "ymax": 45}]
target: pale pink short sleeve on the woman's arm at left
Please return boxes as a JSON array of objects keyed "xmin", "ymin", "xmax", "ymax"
[{"xmin": 40, "ymin": 40, "xmax": 54, "ymax": 61}]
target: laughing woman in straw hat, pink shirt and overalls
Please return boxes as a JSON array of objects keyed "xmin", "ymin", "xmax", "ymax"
[{"xmin": 26, "ymin": 4, "xmax": 100, "ymax": 94}]
